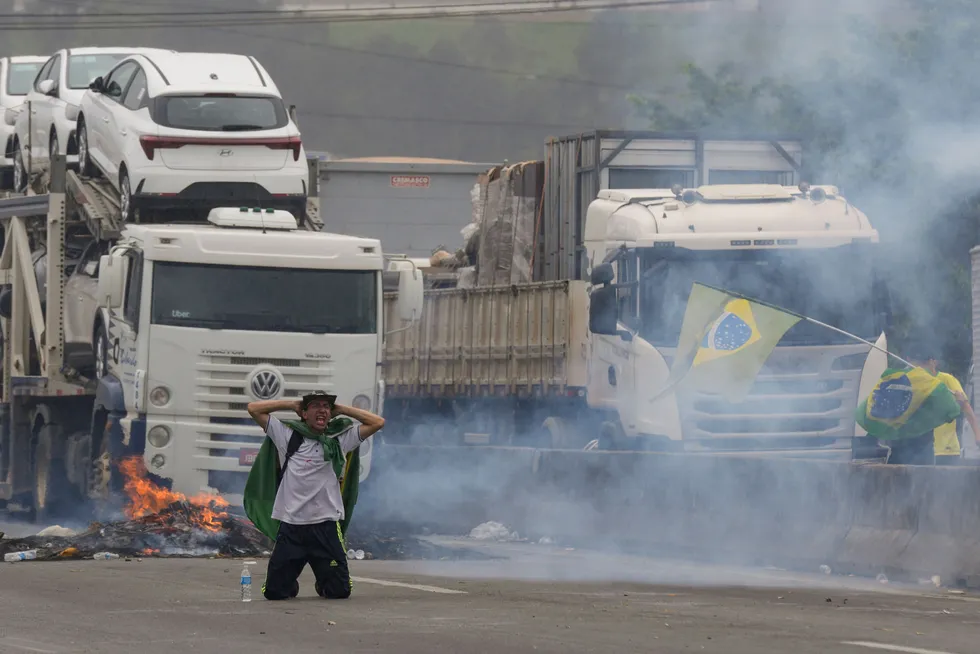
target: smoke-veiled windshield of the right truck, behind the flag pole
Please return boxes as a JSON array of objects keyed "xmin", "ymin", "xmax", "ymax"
[{"xmin": 640, "ymin": 246, "xmax": 881, "ymax": 347}]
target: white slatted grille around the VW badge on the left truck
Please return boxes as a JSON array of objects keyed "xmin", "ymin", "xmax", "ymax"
[{"xmin": 194, "ymin": 356, "xmax": 335, "ymax": 418}]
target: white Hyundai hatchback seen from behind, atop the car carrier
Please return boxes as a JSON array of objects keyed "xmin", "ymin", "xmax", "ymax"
[{"xmin": 76, "ymin": 52, "xmax": 309, "ymax": 220}]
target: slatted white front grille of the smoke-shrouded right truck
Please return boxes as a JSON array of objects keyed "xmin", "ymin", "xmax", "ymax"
[{"xmin": 679, "ymin": 345, "xmax": 868, "ymax": 449}]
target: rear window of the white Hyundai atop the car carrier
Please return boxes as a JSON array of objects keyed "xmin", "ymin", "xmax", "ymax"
[{"xmin": 153, "ymin": 94, "xmax": 289, "ymax": 132}]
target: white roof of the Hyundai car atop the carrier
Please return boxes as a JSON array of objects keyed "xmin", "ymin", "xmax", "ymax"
[{"xmin": 140, "ymin": 51, "xmax": 278, "ymax": 95}]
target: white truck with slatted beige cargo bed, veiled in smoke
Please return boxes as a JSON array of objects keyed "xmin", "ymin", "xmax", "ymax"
[{"xmin": 384, "ymin": 183, "xmax": 887, "ymax": 456}]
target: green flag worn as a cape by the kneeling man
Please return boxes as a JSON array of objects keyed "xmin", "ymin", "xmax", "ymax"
[{"xmin": 242, "ymin": 417, "xmax": 361, "ymax": 540}]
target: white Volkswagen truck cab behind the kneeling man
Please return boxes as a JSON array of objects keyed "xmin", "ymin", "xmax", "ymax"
[{"xmin": 93, "ymin": 208, "xmax": 421, "ymax": 502}]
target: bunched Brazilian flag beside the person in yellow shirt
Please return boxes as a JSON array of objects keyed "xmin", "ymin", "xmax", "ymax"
[{"xmin": 855, "ymin": 368, "xmax": 960, "ymax": 441}]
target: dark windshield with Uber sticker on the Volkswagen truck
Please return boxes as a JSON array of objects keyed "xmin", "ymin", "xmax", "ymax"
[{"xmin": 151, "ymin": 261, "xmax": 379, "ymax": 334}]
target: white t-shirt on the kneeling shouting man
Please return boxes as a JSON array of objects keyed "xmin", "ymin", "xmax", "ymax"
[{"xmin": 265, "ymin": 416, "xmax": 361, "ymax": 525}]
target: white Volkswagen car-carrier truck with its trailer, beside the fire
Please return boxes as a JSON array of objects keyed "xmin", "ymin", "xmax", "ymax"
[{"xmin": 0, "ymin": 156, "xmax": 422, "ymax": 517}]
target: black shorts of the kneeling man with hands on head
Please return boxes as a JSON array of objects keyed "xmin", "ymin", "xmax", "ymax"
[{"xmin": 263, "ymin": 521, "xmax": 353, "ymax": 600}]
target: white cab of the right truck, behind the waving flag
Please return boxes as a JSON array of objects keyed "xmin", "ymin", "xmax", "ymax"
[{"xmin": 585, "ymin": 183, "xmax": 888, "ymax": 454}]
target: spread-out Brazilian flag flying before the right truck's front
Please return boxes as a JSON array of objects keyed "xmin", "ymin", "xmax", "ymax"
[{"xmin": 668, "ymin": 283, "xmax": 802, "ymax": 402}]
